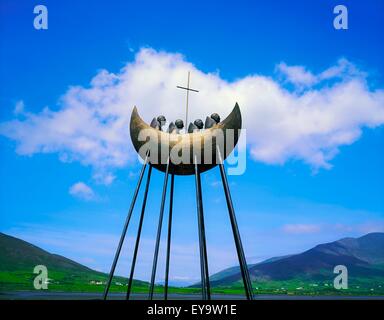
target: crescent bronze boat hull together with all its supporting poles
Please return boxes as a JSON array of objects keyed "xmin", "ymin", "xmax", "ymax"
[{"xmin": 103, "ymin": 103, "xmax": 253, "ymax": 300}]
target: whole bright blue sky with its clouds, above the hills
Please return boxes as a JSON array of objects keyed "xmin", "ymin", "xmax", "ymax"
[{"xmin": 0, "ymin": 1, "xmax": 384, "ymax": 282}]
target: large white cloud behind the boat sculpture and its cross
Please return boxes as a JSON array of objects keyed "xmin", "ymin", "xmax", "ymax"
[{"xmin": 0, "ymin": 49, "xmax": 384, "ymax": 180}]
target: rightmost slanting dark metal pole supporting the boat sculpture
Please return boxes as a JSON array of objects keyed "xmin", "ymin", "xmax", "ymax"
[{"xmin": 217, "ymin": 149, "xmax": 253, "ymax": 300}]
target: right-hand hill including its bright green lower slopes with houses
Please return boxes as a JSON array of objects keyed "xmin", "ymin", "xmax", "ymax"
[{"xmin": 206, "ymin": 232, "xmax": 384, "ymax": 295}]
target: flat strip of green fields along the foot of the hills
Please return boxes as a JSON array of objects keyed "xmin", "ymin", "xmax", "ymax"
[{"xmin": 0, "ymin": 271, "xmax": 384, "ymax": 296}]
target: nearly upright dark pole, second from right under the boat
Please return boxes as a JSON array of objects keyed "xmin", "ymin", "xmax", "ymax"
[{"xmin": 195, "ymin": 156, "xmax": 211, "ymax": 300}]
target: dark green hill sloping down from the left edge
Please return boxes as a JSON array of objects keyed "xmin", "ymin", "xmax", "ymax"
[{"xmin": 0, "ymin": 233, "xmax": 148, "ymax": 292}]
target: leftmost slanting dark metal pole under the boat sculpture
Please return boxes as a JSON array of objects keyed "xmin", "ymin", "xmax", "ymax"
[{"xmin": 103, "ymin": 153, "xmax": 148, "ymax": 300}]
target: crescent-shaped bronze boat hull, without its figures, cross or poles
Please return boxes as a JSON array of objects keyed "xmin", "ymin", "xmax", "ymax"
[{"xmin": 130, "ymin": 103, "xmax": 242, "ymax": 175}]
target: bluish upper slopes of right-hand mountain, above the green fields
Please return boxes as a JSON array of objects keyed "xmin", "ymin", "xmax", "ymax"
[{"xmin": 210, "ymin": 233, "xmax": 384, "ymax": 286}]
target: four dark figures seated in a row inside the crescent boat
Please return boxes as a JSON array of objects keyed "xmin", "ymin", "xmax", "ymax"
[{"xmin": 151, "ymin": 113, "xmax": 220, "ymax": 133}]
